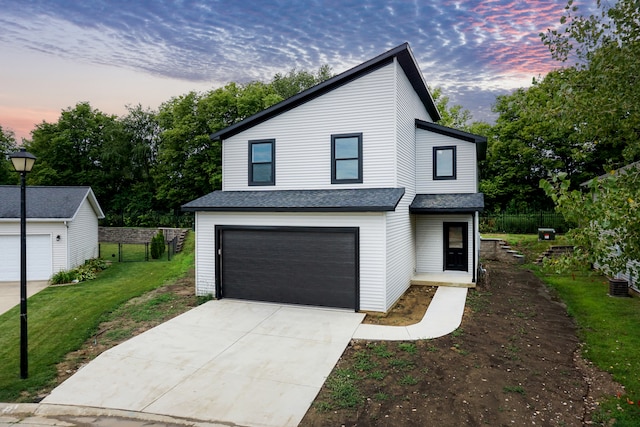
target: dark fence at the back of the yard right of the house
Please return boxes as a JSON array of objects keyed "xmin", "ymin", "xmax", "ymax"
[{"xmin": 480, "ymin": 211, "xmax": 571, "ymax": 234}]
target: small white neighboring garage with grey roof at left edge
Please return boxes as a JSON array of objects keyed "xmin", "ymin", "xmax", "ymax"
[{"xmin": 0, "ymin": 185, "xmax": 104, "ymax": 281}]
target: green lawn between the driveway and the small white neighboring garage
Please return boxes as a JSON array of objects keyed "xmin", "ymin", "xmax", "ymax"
[{"xmin": 0, "ymin": 233, "xmax": 194, "ymax": 402}]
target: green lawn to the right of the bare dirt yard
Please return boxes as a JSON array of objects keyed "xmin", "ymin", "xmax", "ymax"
[{"xmin": 500, "ymin": 235, "xmax": 640, "ymax": 426}]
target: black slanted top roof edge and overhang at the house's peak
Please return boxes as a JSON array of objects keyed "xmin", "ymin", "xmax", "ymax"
[{"xmin": 211, "ymin": 43, "xmax": 441, "ymax": 140}]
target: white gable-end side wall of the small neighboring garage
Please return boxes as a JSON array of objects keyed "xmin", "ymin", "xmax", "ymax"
[{"xmin": 65, "ymin": 198, "xmax": 98, "ymax": 270}]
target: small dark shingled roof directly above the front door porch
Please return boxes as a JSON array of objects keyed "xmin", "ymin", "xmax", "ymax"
[{"xmin": 409, "ymin": 193, "xmax": 484, "ymax": 214}]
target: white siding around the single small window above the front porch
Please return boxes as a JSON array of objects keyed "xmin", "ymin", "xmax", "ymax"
[{"xmin": 416, "ymin": 129, "xmax": 478, "ymax": 194}]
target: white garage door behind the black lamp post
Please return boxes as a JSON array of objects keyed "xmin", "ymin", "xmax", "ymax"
[{"xmin": 0, "ymin": 234, "xmax": 53, "ymax": 281}]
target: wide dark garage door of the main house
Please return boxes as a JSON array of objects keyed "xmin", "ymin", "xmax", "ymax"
[{"xmin": 218, "ymin": 227, "xmax": 359, "ymax": 310}]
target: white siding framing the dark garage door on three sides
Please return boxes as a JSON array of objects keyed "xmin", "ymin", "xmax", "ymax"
[{"xmin": 196, "ymin": 212, "xmax": 386, "ymax": 311}]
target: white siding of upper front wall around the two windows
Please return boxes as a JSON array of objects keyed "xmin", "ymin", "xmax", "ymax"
[{"xmin": 222, "ymin": 64, "xmax": 395, "ymax": 191}]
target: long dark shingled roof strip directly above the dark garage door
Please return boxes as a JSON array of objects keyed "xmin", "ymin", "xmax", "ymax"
[{"xmin": 182, "ymin": 188, "xmax": 404, "ymax": 212}]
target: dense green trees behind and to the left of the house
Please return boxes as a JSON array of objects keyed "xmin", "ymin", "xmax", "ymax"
[{"xmin": 11, "ymin": 65, "xmax": 332, "ymax": 225}]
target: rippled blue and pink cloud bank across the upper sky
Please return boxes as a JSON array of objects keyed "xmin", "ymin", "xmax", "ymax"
[{"xmin": 0, "ymin": 0, "xmax": 580, "ymax": 135}]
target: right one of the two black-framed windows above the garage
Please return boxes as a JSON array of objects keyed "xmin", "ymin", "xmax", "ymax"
[{"xmin": 331, "ymin": 133, "xmax": 362, "ymax": 184}]
